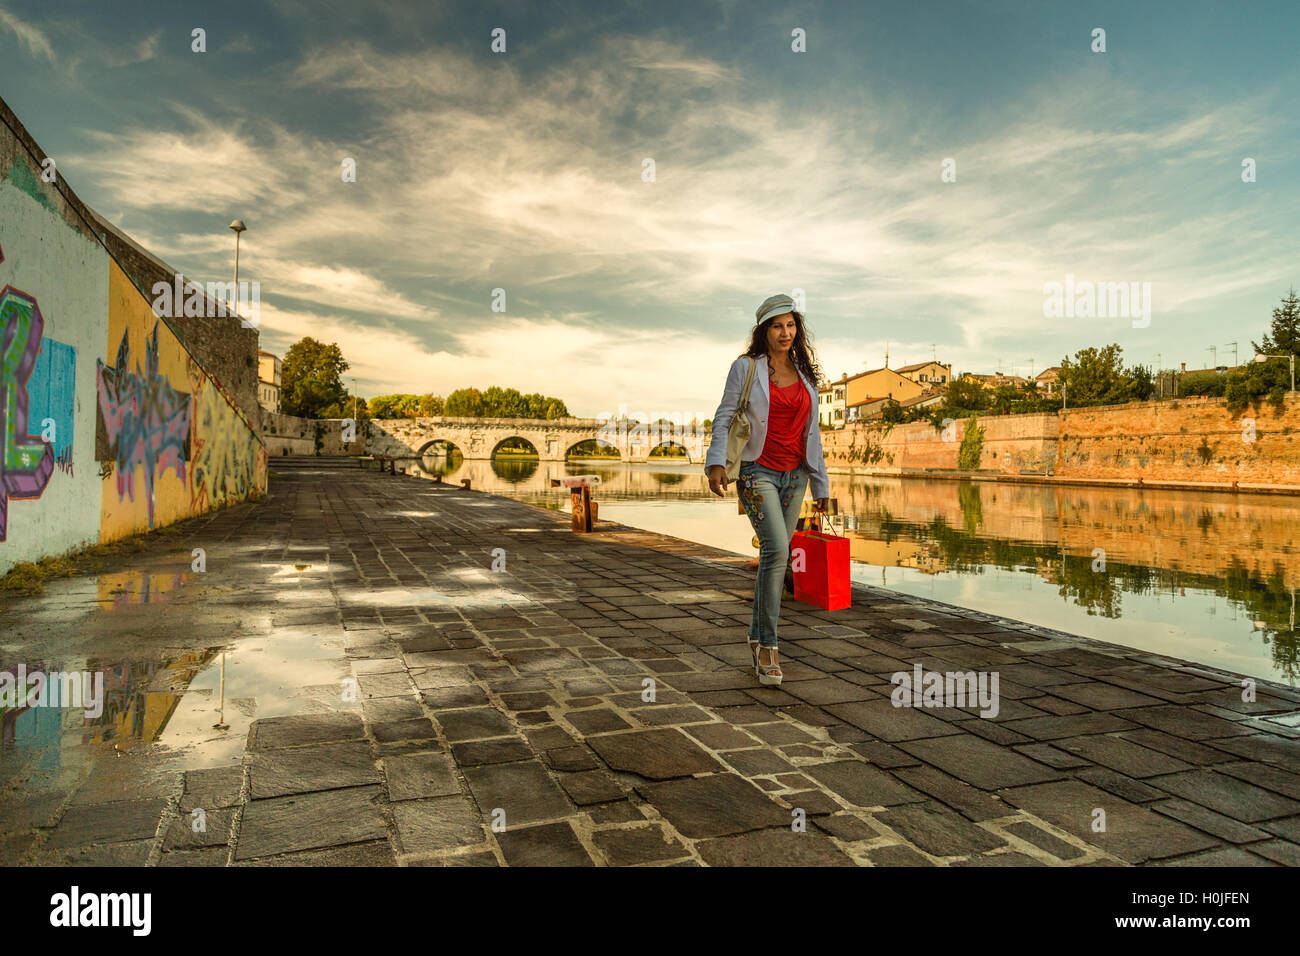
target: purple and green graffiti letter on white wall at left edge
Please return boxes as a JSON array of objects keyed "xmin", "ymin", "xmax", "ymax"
[{"xmin": 0, "ymin": 286, "xmax": 55, "ymax": 541}]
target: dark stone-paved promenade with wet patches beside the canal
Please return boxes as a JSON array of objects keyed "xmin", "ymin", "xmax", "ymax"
[{"xmin": 0, "ymin": 459, "xmax": 1300, "ymax": 866}]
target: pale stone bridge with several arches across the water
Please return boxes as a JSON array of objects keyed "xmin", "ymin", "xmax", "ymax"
[{"xmin": 365, "ymin": 416, "xmax": 710, "ymax": 464}]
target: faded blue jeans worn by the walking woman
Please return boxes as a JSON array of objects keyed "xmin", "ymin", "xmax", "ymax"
[{"xmin": 736, "ymin": 462, "xmax": 809, "ymax": 648}]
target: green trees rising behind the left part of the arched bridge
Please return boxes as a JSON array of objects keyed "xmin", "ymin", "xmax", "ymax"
[{"xmin": 280, "ymin": 337, "xmax": 568, "ymax": 419}]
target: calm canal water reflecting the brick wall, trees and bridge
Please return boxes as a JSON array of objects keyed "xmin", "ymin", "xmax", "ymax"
[{"xmin": 421, "ymin": 455, "xmax": 1300, "ymax": 687}]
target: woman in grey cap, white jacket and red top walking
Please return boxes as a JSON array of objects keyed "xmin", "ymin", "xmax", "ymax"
[{"xmin": 705, "ymin": 295, "xmax": 829, "ymax": 684}]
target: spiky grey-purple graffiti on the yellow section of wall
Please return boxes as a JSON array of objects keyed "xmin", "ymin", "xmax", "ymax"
[{"xmin": 95, "ymin": 321, "xmax": 194, "ymax": 528}]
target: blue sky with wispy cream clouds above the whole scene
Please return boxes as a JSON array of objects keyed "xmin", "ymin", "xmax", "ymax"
[{"xmin": 0, "ymin": 0, "xmax": 1300, "ymax": 418}]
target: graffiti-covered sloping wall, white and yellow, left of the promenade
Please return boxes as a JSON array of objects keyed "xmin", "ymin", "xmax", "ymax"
[{"xmin": 0, "ymin": 100, "xmax": 267, "ymax": 574}]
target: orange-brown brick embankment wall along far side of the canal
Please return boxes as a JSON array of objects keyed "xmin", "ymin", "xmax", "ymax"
[{"xmin": 822, "ymin": 394, "xmax": 1300, "ymax": 490}]
